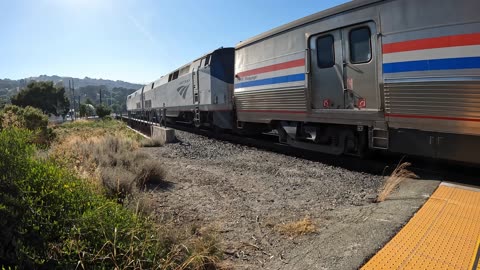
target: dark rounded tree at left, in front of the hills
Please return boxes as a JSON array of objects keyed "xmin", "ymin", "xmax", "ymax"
[{"xmin": 11, "ymin": 82, "xmax": 70, "ymax": 116}]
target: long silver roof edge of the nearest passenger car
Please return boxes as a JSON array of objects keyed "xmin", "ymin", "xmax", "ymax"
[{"xmin": 235, "ymin": 0, "xmax": 385, "ymax": 49}]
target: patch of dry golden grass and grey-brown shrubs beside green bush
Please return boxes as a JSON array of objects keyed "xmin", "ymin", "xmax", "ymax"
[{"xmin": 50, "ymin": 120, "xmax": 166, "ymax": 198}]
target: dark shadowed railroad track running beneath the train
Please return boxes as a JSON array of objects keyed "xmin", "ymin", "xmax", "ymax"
[{"xmin": 121, "ymin": 116, "xmax": 480, "ymax": 185}]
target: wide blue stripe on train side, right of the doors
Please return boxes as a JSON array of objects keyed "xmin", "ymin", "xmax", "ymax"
[{"xmin": 383, "ymin": 57, "xmax": 480, "ymax": 73}]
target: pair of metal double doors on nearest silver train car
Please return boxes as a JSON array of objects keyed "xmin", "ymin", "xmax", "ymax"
[{"xmin": 309, "ymin": 22, "xmax": 380, "ymax": 110}]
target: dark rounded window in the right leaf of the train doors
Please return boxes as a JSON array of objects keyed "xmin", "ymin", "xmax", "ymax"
[{"xmin": 350, "ymin": 27, "xmax": 372, "ymax": 64}]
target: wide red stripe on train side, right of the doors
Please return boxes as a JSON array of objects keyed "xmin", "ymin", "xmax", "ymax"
[{"xmin": 383, "ymin": 33, "xmax": 480, "ymax": 53}]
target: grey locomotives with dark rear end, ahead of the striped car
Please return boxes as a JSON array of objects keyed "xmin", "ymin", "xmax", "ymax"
[{"xmin": 127, "ymin": 48, "xmax": 234, "ymax": 129}]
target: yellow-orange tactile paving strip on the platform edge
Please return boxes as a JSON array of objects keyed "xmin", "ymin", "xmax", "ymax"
[{"xmin": 362, "ymin": 185, "xmax": 480, "ymax": 270}]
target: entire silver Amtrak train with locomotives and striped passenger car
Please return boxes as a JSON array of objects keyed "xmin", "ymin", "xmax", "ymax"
[{"xmin": 127, "ymin": 0, "xmax": 480, "ymax": 163}]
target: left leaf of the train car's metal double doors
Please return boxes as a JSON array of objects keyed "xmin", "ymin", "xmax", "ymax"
[{"xmin": 309, "ymin": 30, "xmax": 344, "ymax": 110}]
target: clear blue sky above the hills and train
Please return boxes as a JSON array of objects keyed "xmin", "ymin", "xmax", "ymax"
[{"xmin": 0, "ymin": 0, "xmax": 348, "ymax": 83}]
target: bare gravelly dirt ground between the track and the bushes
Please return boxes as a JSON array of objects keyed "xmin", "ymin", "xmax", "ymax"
[{"xmin": 143, "ymin": 131, "xmax": 439, "ymax": 269}]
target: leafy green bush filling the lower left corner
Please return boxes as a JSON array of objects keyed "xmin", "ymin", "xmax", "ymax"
[{"xmin": 0, "ymin": 128, "xmax": 180, "ymax": 269}]
